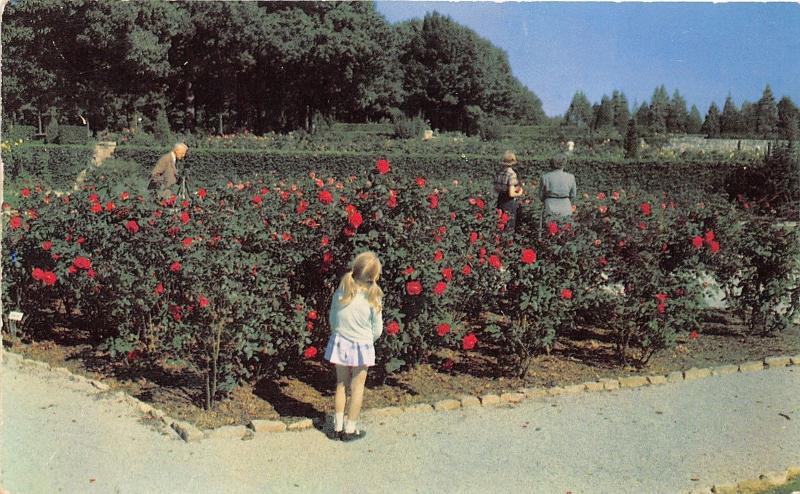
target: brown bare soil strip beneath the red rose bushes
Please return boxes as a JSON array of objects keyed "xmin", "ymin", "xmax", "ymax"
[{"xmin": 4, "ymin": 314, "xmax": 800, "ymax": 428}]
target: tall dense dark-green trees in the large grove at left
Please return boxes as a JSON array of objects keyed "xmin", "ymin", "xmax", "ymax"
[{"xmin": 2, "ymin": 0, "xmax": 545, "ymax": 133}]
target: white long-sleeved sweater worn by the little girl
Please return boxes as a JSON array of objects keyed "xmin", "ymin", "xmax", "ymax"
[{"xmin": 328, "ymin": 290, "xmax": 383, "ymax": 343}]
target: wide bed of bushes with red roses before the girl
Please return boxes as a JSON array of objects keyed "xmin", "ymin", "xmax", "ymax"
[{"xmin": 3, "ymin": 162, "xmax": 800, "ymax": 406}]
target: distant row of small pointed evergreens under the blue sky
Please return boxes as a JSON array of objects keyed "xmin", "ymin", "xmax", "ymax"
[{"xmin": 562, "ymin": 85, "xmax": 800, "ymax": 140}]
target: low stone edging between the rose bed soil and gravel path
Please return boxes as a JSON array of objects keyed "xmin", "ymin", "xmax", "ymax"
[{"xmin": 2, "ymin": 350, "xmax": 800, "ymax": 446}]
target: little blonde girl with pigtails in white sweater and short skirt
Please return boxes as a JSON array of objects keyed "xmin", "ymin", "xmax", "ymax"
[{"xmin": 325, "ymin": 252, "xmax": 383, "ymax": 441}]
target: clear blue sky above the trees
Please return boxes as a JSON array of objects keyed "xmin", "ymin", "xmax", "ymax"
[{"xmin": 376, "ymin": 1, "xmax": 800, "ymax": 115}]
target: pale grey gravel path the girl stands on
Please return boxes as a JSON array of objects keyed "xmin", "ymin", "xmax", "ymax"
[{"xmin": 0, "ymin": 358, "xmax": 800, "ymax": 494}]
